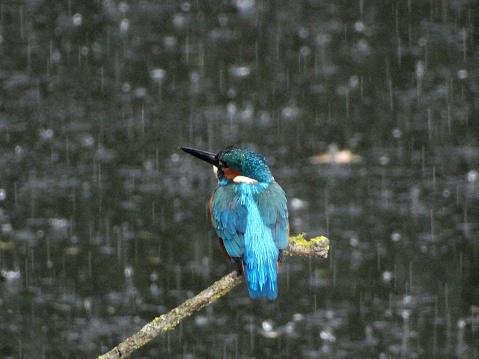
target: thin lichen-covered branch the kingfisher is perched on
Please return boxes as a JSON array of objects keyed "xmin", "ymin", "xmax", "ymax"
[{"xmin": 98, "ymin": 233, "xmax": 329, "ymax": 359}]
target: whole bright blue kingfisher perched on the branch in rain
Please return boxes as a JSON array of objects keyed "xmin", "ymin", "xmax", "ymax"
[{"xmin": 181, "ymin": 146, "xmax": 289, "ymax": 300}]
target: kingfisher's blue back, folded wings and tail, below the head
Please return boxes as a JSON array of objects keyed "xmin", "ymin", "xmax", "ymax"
[{"xmin": 212, "ymin": 182, "xmax": 288, "ymax": 299}]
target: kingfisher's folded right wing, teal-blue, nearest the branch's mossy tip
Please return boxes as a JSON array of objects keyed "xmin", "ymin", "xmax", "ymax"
[{"xmin": 256, "ymin": 182, "xmax": 289, "ymax": 249}]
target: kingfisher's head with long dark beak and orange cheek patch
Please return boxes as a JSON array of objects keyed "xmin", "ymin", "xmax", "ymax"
[{"xmin": 181, "ymin": 147, "xmax": 274, "ymax": 183}]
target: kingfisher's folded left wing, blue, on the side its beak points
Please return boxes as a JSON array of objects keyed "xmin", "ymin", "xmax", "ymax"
[{"xmin": 210, "ymin": 185, "xmax": 247, "ymax": 257}]
